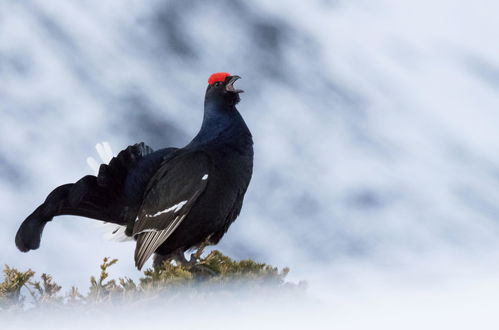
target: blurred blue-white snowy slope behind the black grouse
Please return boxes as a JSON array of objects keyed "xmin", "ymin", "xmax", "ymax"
[{"xmin": 0, "ymin": 0, "xmax": 499, "ymax": 329}]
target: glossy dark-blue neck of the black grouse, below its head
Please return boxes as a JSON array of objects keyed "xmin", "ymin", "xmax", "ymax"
[{"xmin": 189, "ymin": 103, "xmax": 251, "ymax": 146}]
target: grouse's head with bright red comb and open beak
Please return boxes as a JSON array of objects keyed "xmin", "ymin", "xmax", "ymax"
[{"xmin": 205, "ymin": 72, "xmax": 243, "ymax": 106}]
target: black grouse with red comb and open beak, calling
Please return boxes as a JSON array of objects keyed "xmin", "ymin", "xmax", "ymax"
[{"xmin": 15, "ymin": 72, "xmax": 254, "ymax": 270}]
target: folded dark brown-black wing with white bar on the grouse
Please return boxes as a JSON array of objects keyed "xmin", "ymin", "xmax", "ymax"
[{"xmin": 133, "ymin": 152, "xmax": 210, "ymax": 269}]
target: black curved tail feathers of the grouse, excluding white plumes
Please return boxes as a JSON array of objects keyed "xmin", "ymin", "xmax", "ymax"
[{"xmin": 16, "ymin": 143, "xmax": 156, "ymax": 252}]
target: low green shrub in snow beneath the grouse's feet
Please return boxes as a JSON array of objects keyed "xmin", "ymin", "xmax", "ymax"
[{"xmin": 0, "ymin": 250, "xmax": 305, "ymax": 311}]
